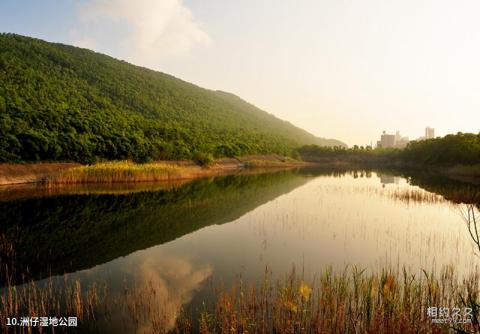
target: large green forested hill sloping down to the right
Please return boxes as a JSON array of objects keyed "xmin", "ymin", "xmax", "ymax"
[{"xmin": 0, "ymin": 34, "xmax": 343, "ymax": 162}]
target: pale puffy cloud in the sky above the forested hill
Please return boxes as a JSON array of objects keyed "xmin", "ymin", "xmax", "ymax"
[{"xmin": 72, "ymin": 0, "xmax": 210, "ymax": 65}]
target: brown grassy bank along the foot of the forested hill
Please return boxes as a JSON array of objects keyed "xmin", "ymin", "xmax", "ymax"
[{"xmin": 0, "ymin": 155, "xmax": 312, "ymax": 187}]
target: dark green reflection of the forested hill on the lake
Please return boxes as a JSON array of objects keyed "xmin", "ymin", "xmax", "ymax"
[{"xmin": 0, "ymin": 171, "xmax": 308, "ymax": 284}]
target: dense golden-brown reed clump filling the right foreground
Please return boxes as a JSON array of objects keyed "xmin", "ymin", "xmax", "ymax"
[{"xmin": 200, "ymin": 268, "xmax": 479, "ymax": 333}]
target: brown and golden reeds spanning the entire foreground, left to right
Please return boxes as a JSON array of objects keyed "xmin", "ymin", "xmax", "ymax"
[{"xmin": 0, "ymin": 267, "xmax": 480, "ymax": 334}]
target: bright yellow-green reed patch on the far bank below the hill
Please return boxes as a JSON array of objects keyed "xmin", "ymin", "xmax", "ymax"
[{"xmin": 47, "ymin": 161, "xmax": 190, "ymax": 185}]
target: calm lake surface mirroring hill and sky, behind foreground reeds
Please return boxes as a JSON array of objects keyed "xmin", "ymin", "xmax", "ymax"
[{"xmin": 0, "ymin": 168, "xmax": 480, "ymax": 332}]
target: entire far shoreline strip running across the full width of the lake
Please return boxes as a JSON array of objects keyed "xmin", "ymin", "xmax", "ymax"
[{"xmin": 0, "ymin": 155, "xmax": 480, "ymax": 188}]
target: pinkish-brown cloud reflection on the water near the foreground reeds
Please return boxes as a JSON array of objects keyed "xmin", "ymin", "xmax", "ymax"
[{"xmin": 135, "ymin": 256, "xmax": 212, "ymax": 333}]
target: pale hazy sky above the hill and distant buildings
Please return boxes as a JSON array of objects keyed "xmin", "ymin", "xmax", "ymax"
[{"xmin": 0, "ymin": 0, "xmax": 480, "ymax": 145}]
